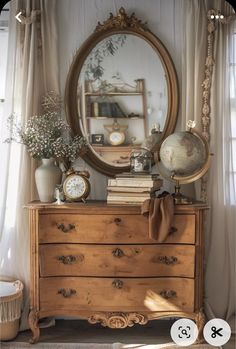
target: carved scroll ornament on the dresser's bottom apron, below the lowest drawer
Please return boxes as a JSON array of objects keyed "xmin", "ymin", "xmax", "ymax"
[{"xmin": 88, "ymin": 313, "xmax": 148, "ymax": 328}]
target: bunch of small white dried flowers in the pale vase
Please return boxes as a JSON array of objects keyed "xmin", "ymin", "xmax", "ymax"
[{"xmin": 6, "ymin": 110, "xmax": 87, "ymax": 168}]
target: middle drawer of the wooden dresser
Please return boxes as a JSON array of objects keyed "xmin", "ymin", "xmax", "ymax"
[{"xmin": 40, "ymin": 244, "xmax": 195, "ymax": 277}]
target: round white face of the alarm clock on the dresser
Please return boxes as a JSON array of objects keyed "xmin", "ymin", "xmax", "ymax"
[{"xmin": 63, "ymin": 175, "xmax": 88, "ymax": 200}]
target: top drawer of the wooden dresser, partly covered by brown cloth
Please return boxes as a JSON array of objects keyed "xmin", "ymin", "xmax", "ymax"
[{"xmin": 39, "ymin": 213, "xmax": 195, "ymax": 244}]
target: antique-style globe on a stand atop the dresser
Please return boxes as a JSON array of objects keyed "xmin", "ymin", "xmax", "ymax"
[{"xmin": 158, "ymin": 129, "xmax": 211, "ymax": 204}]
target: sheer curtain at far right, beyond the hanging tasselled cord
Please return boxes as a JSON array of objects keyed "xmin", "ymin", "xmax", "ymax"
[{"xmin": 206, "ymin": 6, "xmax": 236, "ymax": 331}]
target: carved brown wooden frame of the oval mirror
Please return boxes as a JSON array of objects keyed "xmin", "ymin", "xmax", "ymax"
[{"xmin": 65, "ymin": 8, "xmax": 179, "ymax": 176}]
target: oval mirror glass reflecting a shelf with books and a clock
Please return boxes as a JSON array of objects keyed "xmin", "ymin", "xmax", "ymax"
[{"xmin": 78, "ymin": 34, "xmax": 168, "ymax": 165}]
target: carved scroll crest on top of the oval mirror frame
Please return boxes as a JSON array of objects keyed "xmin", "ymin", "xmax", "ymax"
[{"xmin": 95, "ymin": 7, "xmax": 147, "ymax": 32}]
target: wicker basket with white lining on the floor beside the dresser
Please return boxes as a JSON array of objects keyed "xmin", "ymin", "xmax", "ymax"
[{"xmin": 0, "ymin": 278, "xmax": 23, "ymax": 341}]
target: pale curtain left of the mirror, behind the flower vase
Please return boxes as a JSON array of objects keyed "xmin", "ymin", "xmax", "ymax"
[{"xmin": 0, "ymin": 0, "xmax": 59, "ymax": 329}]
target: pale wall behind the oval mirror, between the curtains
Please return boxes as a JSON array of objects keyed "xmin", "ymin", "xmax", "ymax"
[{"xmin": 57, "ymin": 0, "xmax": 186, "ymax": 199}]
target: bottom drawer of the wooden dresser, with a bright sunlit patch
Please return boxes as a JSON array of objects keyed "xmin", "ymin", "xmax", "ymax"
[{"xmin": 39, "ymin": 277, "xmax": 194, "ymax": 314}]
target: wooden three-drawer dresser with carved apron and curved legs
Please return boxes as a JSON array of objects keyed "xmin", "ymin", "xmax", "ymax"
[{"xmin": 27, "ymin": 202, "xmax": 207, "ymax": 343}]
